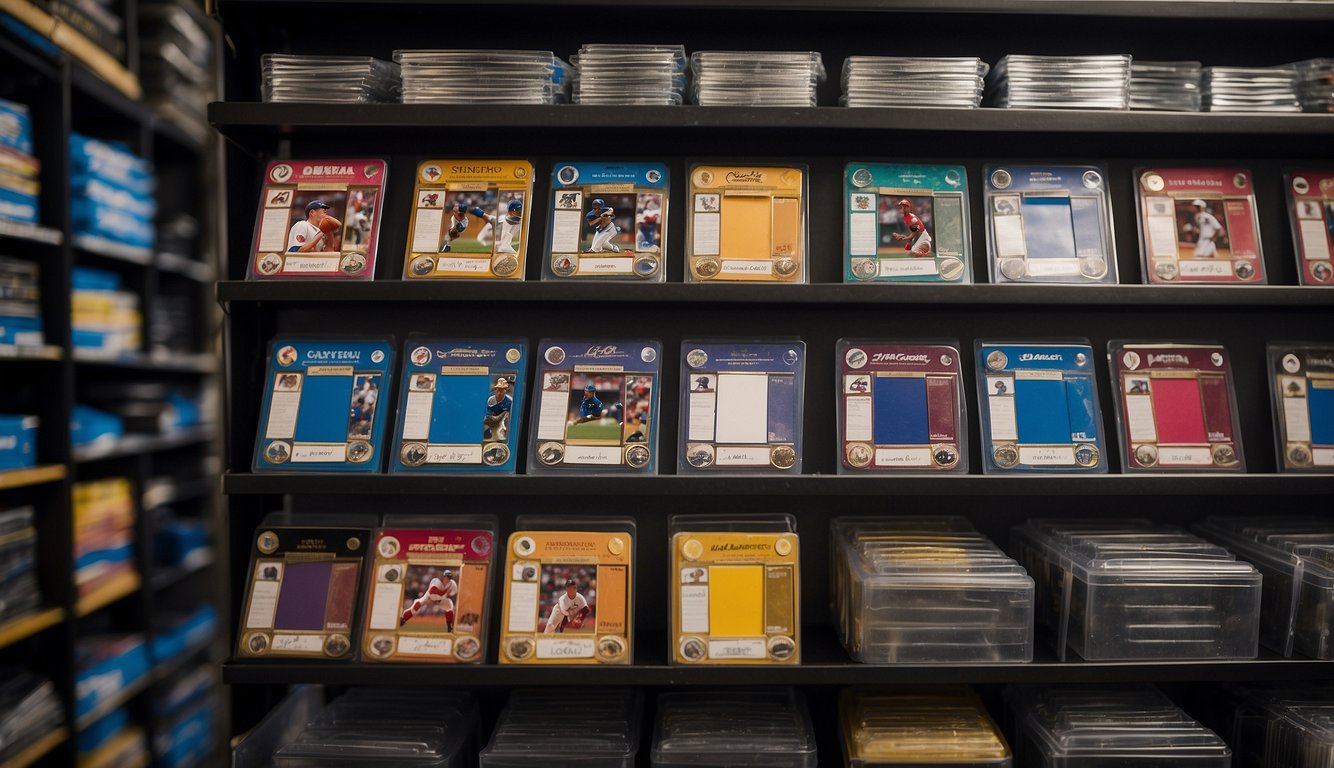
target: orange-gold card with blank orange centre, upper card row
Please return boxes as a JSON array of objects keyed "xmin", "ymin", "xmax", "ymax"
[{"xmin": 686, "ymin": 165, "xmax": 806, "ymax": 283}]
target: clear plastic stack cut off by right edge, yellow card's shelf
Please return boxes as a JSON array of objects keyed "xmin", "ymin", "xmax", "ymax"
[{"xmin": 1195, "ymin": 516, "xmax": 1334, "ymax": 659}]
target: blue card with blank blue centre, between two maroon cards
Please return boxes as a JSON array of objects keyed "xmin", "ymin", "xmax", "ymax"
[{"xmin": 976, "ymin": 340, "xmax": 1107, "ymax": 473}]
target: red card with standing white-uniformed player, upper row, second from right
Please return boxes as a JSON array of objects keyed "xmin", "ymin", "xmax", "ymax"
[{"xmin": 1135, "ymin": 168, "xmax": 1265, "ymax": 285}]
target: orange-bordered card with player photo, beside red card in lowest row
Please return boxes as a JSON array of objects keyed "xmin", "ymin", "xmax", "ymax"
[{"xmin": 500, "ymin": 515, "xmax": 635, "ymax": 664}]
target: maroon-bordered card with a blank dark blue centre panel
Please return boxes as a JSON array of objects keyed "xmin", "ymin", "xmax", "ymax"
[{"xmin": 835, "ymin": 339, "xmax": 968, "ymax": 473}]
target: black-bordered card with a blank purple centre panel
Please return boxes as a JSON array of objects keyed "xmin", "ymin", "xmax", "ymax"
[{"xmin": 236, "ymin": 512, "xmax": 375, "ymax": 659}]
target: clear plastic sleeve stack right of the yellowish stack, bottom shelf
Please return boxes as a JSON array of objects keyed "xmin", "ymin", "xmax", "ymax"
[{"xmin": 1005, "ymin": 685, "xmax": 1233, "ymax": 768}]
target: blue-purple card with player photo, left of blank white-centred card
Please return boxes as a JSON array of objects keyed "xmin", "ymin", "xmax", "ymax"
[{"xmin": 528, "ymin": 339, "xmax": 662, "ymax": 475}]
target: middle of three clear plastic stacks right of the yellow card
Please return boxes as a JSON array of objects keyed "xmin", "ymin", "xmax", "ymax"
[{"xmin": 1010, "ymin": 519, "xmax": 1261, "ymax": 661}]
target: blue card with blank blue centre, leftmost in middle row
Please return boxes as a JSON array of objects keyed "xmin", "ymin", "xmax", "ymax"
[{"xmin": 255, "ymin": 337, "xmax": 394, "ymax": 472}]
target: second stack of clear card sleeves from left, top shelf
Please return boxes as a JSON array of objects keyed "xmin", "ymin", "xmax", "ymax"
[{"xmin": 394, "ymin": 49, "xmax": 570, "ymax": 104}]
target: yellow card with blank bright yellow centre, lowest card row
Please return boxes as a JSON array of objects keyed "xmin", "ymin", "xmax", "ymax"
[{"xmin": 667, "ymin": 515, "xmax": 802, "ymax": 664}]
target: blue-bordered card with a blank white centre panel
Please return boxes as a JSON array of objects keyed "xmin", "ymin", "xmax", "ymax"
[{"xmin": 676, "ymin": 339, "xmax": 806, "ymax": 475}]
